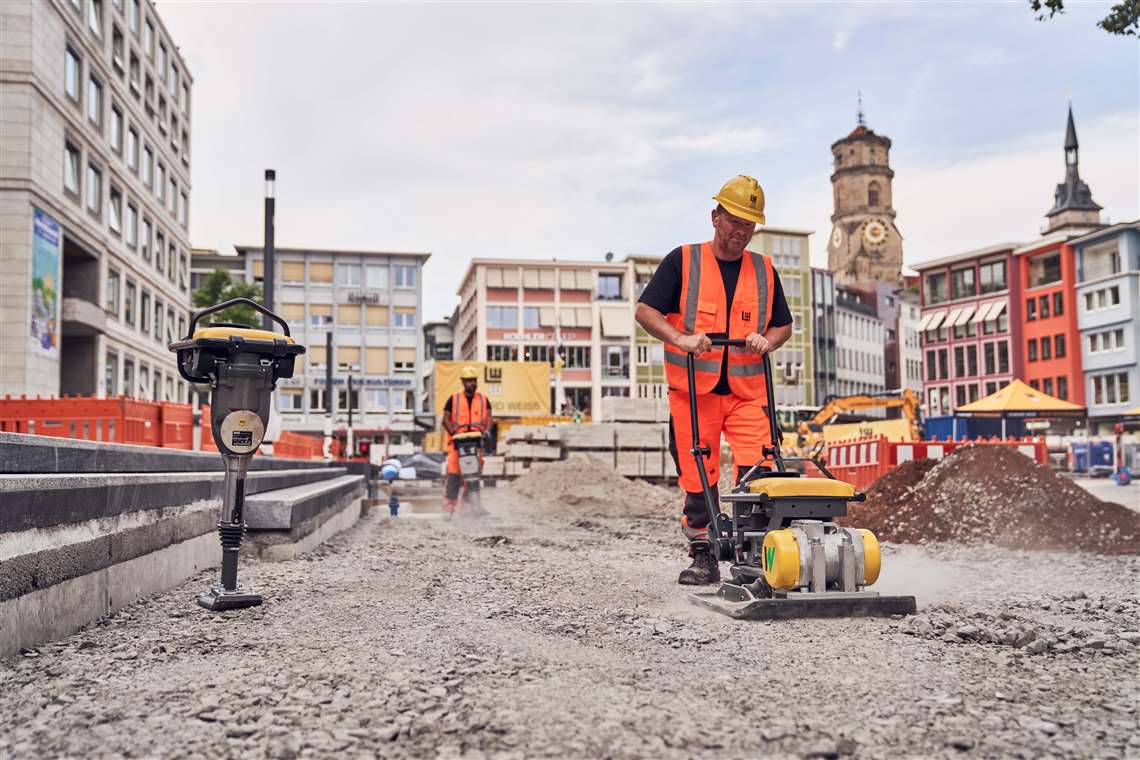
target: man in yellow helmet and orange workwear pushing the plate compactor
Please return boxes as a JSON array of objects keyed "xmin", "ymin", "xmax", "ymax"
[{"xmin": 635, "ymin": 175, "xmax": 792, "ymax": 586}]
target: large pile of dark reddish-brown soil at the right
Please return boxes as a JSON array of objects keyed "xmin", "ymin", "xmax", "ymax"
[{"xmin": 844, "ymin": 446, "xmax": 1140, "ymax": 554}]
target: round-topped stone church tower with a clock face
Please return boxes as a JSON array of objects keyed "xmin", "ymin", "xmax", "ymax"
[{"xmin": 828, "ymin": 98, "xmax": 903, "ymax": 286}]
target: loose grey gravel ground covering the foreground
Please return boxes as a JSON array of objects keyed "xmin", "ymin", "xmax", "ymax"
[{"xmin": 0, "ymin": 494, "xmax": 1140, "ymax": 759}]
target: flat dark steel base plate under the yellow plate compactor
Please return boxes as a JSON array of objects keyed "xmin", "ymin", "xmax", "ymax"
[{"xmin": 689, "ymin": 583, "xmax": 917, "ymax": 620}]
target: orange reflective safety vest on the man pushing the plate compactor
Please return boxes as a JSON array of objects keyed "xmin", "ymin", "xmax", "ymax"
[{"xmin": 665, "ymin": 243, "xmax": 775, "ymax": 399}]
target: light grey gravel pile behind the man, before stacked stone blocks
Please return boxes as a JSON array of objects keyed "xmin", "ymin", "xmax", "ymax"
[{"xmin": 508, "ymin": 453, "xmax": 681, "ymax": 517}]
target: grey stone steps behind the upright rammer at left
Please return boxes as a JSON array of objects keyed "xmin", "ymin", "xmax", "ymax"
[{"xmin": 0, "ymin": 433, "xmax": 367, "ymax": 656}]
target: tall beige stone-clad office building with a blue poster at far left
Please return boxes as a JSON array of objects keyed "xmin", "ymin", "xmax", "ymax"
[{"xmin": 0, "ymin": 0, "xmax": 193, "ymax": 400}]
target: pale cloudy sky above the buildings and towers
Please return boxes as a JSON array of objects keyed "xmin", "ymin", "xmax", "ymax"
[{"xmin": 158, "ymin": 0, "xmax": 1140, "ymax": 319}]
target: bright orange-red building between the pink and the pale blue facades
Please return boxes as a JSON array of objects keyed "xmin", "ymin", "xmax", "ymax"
[{"xmin": 1013, "ymin": 231, "xmax": 1084, "ymax": 406}]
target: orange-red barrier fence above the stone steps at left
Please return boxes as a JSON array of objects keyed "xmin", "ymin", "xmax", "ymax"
[{"xmin": 0, "ymin": 397, "xmax": 321, "ymax": 459}]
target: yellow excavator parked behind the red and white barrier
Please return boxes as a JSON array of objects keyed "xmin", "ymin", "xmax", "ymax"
[{"xmin": 796, "ymin": 387, "xmax": 922, "ymax": 451}]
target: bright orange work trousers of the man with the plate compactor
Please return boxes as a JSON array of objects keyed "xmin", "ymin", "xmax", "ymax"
[{"xmin": 669, "ymin": 389, "xmax": 772, "ymax": 496}]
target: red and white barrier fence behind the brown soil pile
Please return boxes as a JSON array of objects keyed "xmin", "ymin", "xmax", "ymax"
[{"xmin": 827, "ymin": 436, "xmax": 1049, "ymax": 490}]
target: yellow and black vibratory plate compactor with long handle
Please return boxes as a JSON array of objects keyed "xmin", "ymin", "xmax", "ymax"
[{"xmin": 689, "ymin": 338, "xmax": 915, "ymax": 620}]
